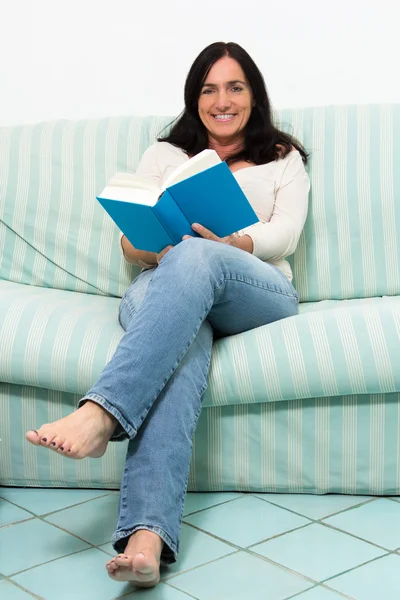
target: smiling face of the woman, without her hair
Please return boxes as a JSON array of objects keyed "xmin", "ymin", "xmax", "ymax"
[{"xmin": 198, "ymin": 56, "xmax": 253, "ymax": 143}]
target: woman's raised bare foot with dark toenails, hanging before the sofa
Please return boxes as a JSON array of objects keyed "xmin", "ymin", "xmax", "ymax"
[{"xmin": 25, "ymin": 400, "xmax": 118, "ymax": 459}]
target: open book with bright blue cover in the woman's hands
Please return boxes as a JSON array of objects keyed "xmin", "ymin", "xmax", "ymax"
[{"xmin": 97, "ymin": 150, "xmax": 258, "ymax": 252}]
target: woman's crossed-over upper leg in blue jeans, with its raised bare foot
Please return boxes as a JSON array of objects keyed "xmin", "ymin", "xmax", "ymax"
[{"xmin": 25, "ymin": 238, "xmax": 297, "ymax": 458}]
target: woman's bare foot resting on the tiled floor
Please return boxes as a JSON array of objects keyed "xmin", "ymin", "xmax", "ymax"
[{"xmin": 106, "ymin": 529, "xmax": 164, "ymax": 587}]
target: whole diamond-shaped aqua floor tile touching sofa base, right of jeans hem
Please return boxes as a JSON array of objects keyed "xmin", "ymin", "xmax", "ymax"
[{"xmin": 184, "ymin": 496, "xmax": 309, "ymax": 548}]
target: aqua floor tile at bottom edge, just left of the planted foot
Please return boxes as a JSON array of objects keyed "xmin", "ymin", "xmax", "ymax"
[{"xmin": 13, "ymin": 548, "xmax": 132, "ymax": 600}]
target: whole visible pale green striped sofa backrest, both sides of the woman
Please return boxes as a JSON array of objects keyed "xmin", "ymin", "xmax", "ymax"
[{"xmin": 0, "ymin": 105, "xmax": 400, "ymax": 301}]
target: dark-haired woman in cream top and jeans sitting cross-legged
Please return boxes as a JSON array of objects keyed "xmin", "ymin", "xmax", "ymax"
[{"xmin": 27, "ymin": 42, "xmax": 309, "ymax": 587}]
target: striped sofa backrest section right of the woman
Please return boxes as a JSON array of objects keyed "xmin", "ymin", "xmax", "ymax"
[{"xmin": 277, "ymin": 104, "xmax": 400, "ymax": 302}]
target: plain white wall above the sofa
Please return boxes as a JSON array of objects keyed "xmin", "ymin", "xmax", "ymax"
[{"xmin": 0, "ymin": 0, "xmax": 400, "ymax": 124}]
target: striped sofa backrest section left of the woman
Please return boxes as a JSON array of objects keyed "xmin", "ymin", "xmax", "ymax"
[{"xmin": 0, "ymin": 117, "xmax": 169, "ymax": 296}]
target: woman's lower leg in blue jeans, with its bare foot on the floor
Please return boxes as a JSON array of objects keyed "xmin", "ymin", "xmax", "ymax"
[{"xmin": 107, "ymin": 321, "xmax": 213, "ymax": 585}]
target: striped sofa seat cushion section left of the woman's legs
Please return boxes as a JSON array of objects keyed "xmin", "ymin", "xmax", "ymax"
[{"xmin": 0, "ymin": 281, "xmax": 124, "ymax": 393}]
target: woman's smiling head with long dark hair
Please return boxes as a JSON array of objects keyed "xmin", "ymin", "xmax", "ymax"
[{"xmin": 159, "ymin": 42, "xmax": 307, "ymax": 170}]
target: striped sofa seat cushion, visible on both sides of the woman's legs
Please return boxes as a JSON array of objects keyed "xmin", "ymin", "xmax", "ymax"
[{"xmin": 0, "ymin": 282, "xmax": 400, "ymax": 406}]
